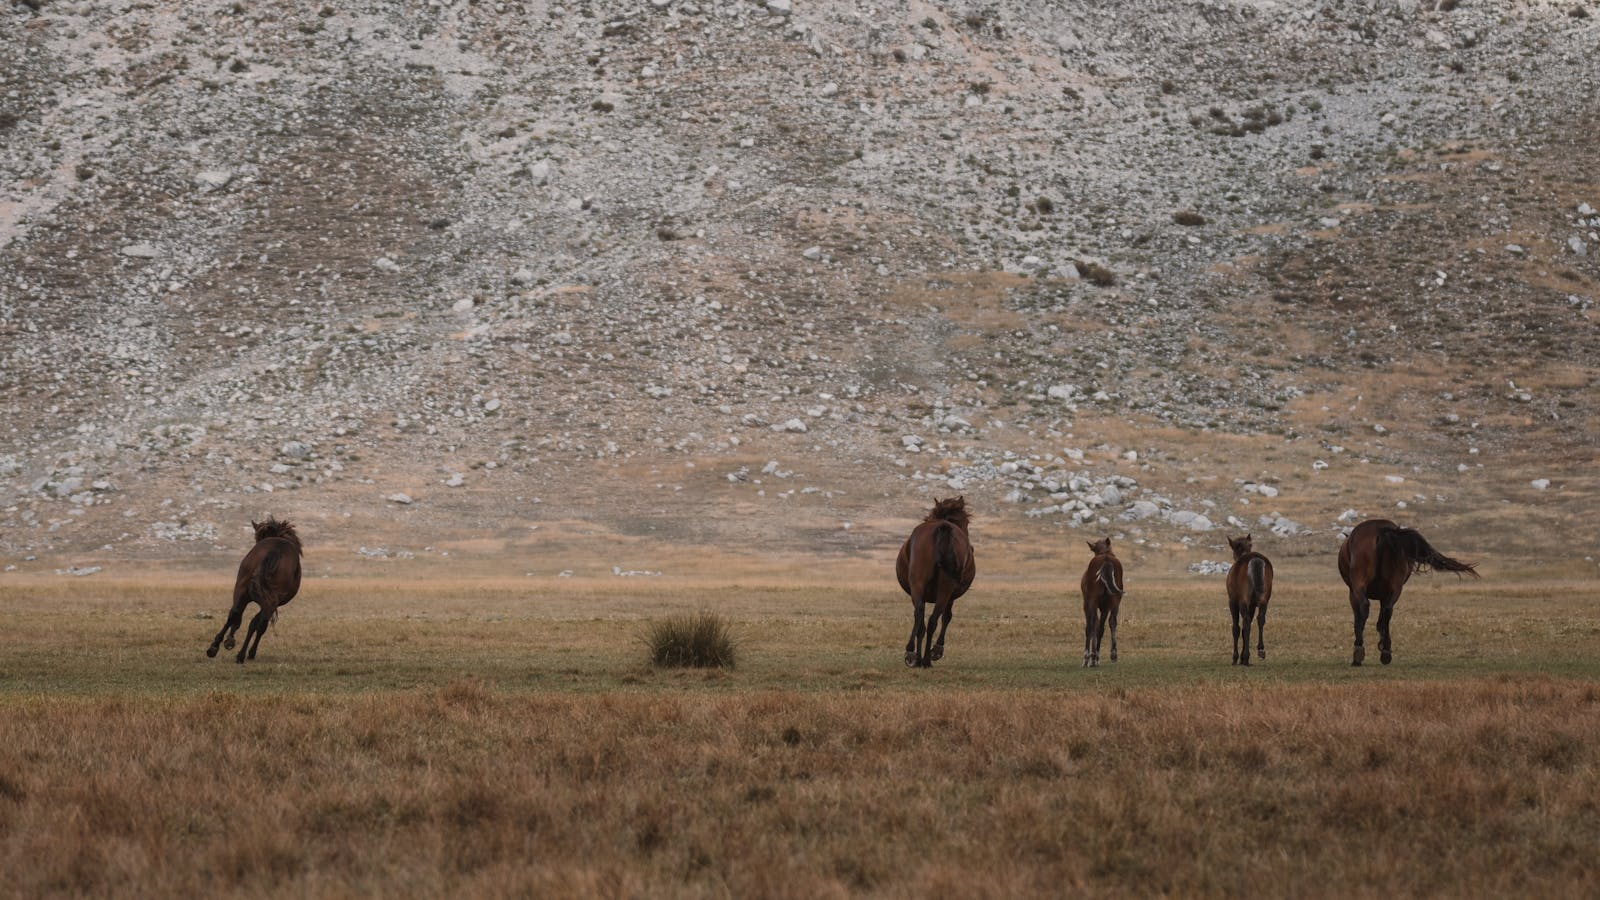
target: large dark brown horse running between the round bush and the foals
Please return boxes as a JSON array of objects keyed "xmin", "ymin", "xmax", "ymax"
[{"xmin": 894, "ymin": 496, "xmax": 978, "ymax": 668}]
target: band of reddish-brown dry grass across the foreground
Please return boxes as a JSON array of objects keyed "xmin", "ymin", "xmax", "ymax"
[{"xmin": 0, "ymin": 677, "xmax": 1600, "ymax": 897}]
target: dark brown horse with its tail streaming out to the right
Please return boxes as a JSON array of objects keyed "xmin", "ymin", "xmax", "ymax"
[{"xmin": 1339, "ymin": 519, "xmax": 1478, "ymax": 666}]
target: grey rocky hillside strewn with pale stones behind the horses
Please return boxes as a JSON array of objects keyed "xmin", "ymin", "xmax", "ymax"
[{"xmin": 0, "ymin": 0, "xmax": 1600, "ymax": 572}]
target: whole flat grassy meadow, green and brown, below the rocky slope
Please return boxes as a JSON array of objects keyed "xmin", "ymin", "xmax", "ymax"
[{"xmin": 0, "ymin": 565, "xmax": 1600, "ymax": 897}]
